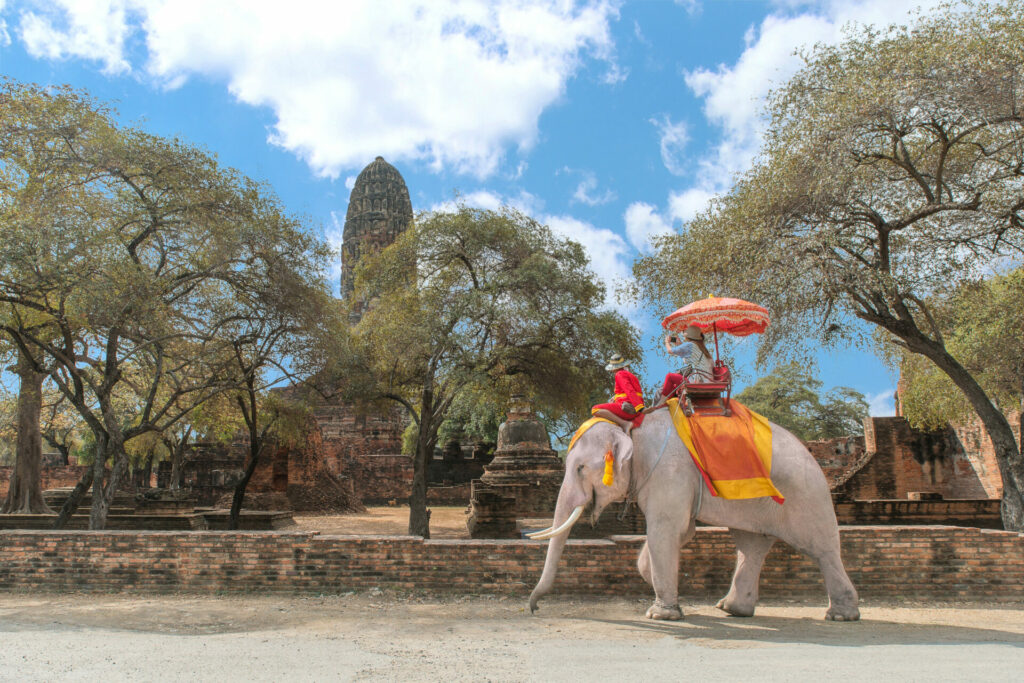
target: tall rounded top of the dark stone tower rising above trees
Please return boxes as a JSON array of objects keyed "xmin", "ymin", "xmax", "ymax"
[{"xmin": 341, "ymin": 157, "xmax": 413, "ymax": 309}]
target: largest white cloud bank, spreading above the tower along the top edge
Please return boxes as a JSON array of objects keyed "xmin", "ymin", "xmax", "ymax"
[{"xmin": 8, "ymin": 0, "xmax": 625, "ymax": 176}]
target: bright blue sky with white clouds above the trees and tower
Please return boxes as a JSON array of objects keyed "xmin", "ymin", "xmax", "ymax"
[{"xmin": 0, "ymin": 0, "xmax": 958, "ymax": 415}]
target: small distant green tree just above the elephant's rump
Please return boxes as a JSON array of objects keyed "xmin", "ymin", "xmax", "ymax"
[{"xmin": 736, "ymin": 362, "xmax": 868, "ymax": 441}]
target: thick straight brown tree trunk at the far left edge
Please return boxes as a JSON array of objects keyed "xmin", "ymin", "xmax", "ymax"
[{"xmin": 0, "ymin": 349, "xmax": 53, "ymax": 514}]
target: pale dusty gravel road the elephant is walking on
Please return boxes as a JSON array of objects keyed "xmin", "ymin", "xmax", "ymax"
[{"xmin": 0, "ymin": 591, "xmax": 1024, "ymax": 682}]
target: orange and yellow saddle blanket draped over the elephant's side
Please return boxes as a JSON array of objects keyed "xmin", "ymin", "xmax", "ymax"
[{"xmin": 668, "ymin": 398, "xmax": 784, "ymax": 504}]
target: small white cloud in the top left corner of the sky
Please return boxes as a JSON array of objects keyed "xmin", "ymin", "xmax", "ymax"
[{"xmin": 16, "ymin": 0, "xmax": 132, "ymax": 74}]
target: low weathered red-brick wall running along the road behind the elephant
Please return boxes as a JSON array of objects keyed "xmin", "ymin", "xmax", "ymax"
[{"xmin": 0, "ymin": 526, "xmax": 1024, "ymax": 603}]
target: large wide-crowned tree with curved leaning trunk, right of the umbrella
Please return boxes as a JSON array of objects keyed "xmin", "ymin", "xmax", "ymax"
[{"xmin": 635, "ymin": 2, "xmax": 1024, "ymax": 529}]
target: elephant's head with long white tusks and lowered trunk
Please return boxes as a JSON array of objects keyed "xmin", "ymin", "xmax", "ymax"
[{"xmin": 529, "ymin": 422, "xmax": 633, "ymax": 612}]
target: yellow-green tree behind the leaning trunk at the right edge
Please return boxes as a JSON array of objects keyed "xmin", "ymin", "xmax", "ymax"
[{"xmin": 893, "ymin": 268, "xmax": 1024, "ymax": 429}]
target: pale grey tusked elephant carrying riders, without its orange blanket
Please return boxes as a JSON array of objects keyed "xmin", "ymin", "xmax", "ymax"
[{"xmin": 529, "ymin": 409, "xmax": 860, "ymax": 622}]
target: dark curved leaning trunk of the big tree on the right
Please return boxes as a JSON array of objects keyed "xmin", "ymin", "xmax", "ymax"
[{"xmin": 900, "ymin": 327, "xmax": 1024, "ymax": 531}]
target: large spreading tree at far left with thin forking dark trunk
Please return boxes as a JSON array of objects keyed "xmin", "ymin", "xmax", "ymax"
[{"xmin": 0, "ymin": 82, "xmax": 323, "ymax": 528}]
